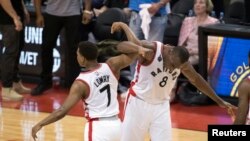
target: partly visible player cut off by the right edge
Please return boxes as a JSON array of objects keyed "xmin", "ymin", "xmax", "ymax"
[{"xmin": 234, "ymin": 50, "xmax": 250, "ymax": 125}]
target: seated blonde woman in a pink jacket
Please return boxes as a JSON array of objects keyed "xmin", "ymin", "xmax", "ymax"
[{"xmin": 178, "ymin": 0, "xmax": 219, "ymax": 65}]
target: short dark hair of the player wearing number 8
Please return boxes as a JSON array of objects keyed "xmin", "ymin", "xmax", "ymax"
[{"xmin": 173, "ymin": 46, "xmax": 189, "ymax": 63}]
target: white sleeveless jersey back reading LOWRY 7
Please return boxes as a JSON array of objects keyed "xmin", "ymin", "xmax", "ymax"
[{"xmin": 76, "ymin": 63, "xmax": 119, "ymax": 118}]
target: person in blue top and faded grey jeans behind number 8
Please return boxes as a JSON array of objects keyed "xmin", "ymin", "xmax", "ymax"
[{"xmin": 129, "ymin": 0, "xmax": 170, "ymax": 41}]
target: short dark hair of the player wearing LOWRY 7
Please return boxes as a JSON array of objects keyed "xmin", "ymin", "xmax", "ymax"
[{"xmin": 78, "ymin": 41, "xmax": 98, "ymax": 60}]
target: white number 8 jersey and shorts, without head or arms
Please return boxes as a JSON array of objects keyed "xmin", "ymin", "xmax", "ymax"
[{"xmin": 121, "ymin": 42, "xmax": 180, "ymax": 141}]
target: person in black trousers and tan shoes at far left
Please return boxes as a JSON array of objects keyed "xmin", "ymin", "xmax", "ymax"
[{"xmin": 0, "ymin": 0, "xmax": 30, "ymax": 101}]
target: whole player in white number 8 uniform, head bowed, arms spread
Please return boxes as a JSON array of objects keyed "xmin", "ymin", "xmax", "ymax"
[{"xmin": 112, "ymin": 22, "xmax": 236, "ymax": 141}]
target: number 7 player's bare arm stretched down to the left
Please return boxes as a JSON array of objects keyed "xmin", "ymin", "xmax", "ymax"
[{"xmin": 31, "ymin": 81, "xmax": 87, "ymax": 140}]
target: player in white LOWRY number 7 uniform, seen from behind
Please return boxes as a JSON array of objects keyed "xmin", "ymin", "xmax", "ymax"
[{"xmin": 32, "ymin": 41, "xmax": 153, "ymax": 141}]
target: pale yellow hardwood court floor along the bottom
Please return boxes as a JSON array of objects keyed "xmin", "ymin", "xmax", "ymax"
[{"xmin": 0, "ymin": 108, "xmax": 207, "ymax": 141}]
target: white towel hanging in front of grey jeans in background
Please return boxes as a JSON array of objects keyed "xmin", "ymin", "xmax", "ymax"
[{"xmin": 139, "ymin": 4, "xmax": 152, "ymax": 40}]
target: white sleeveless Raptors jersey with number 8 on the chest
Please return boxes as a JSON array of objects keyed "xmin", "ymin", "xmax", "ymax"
[{"xmin": 129, "ymin": 42, "xmax": 180, "ymax": 104}]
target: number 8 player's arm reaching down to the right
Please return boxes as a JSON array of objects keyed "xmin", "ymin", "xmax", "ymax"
[{"xmin": 180, "ymin": 62, "xmax": 236, "ymax": 109}]
